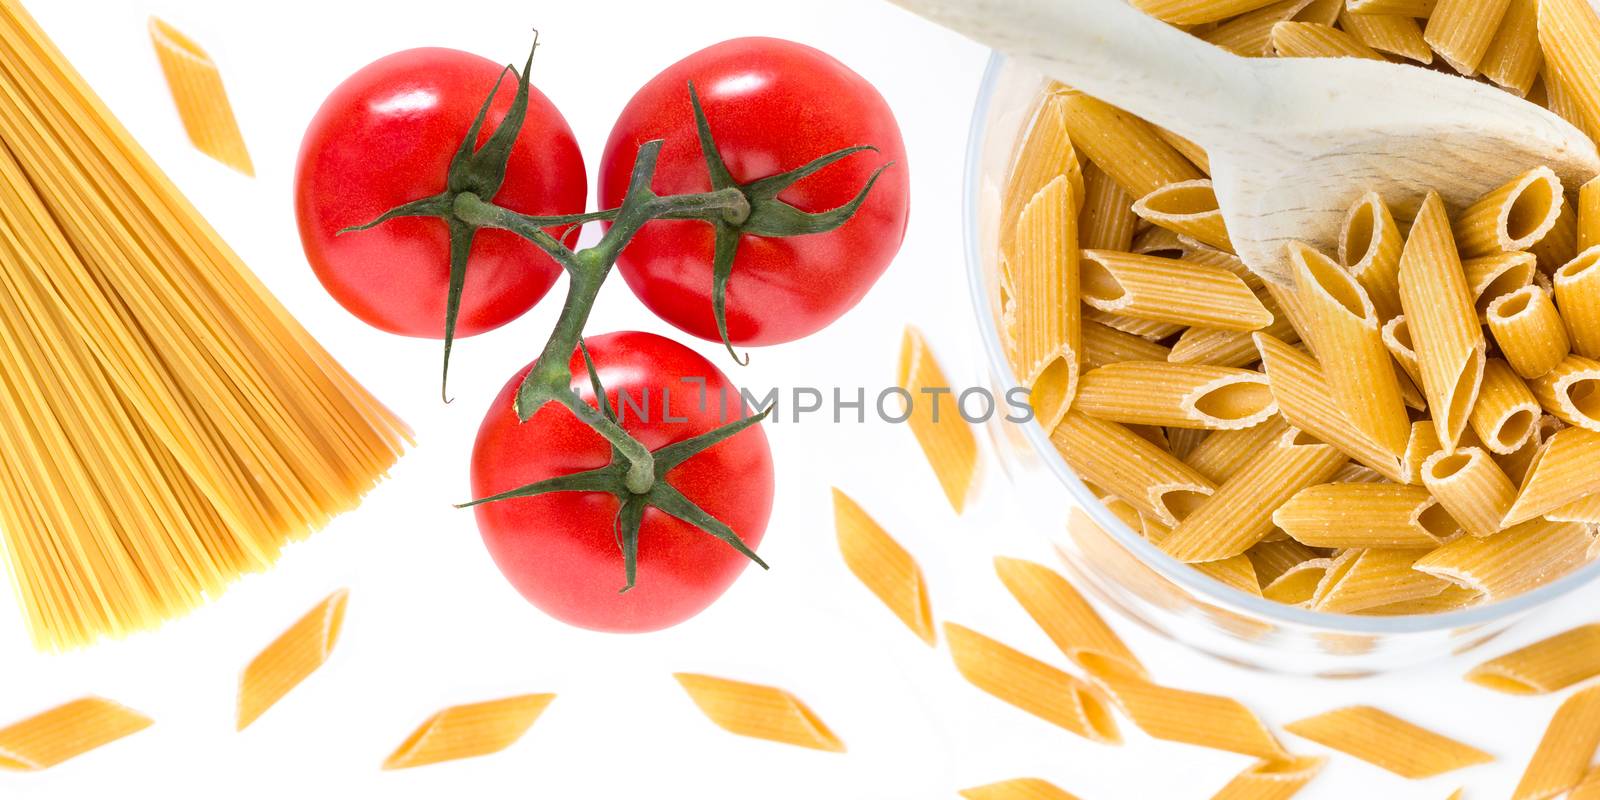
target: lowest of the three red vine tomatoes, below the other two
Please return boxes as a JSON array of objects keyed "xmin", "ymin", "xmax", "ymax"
[{"xmin": 472, "ymin": 331, "xmax": 773, "ymax": 632}]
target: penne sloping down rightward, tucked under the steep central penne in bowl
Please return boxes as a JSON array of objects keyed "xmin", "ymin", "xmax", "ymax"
[{"xmin": 1256, "ymin": 334, "xmax": 1405, "ymax": 483}]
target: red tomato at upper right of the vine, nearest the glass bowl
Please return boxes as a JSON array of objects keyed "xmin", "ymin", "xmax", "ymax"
[{"xmin": 600, "ymin": 38, "xmax": 910, "ymax": 344}]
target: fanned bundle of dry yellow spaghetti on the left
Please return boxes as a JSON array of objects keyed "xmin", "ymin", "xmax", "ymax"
[{"xmin": 0, "ymin": 0, "xmax": 410, "ymax": 648}]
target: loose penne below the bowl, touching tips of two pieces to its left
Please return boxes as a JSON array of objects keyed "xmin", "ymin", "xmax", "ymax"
[{"xmin": 1096, "ymin": 675, "xmax": 1288, "ymax": 758}]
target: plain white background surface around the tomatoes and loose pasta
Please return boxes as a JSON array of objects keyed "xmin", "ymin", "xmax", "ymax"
[{"xmin": 0, "ymin": 0, "xmax": 1600, "ymax": 800}]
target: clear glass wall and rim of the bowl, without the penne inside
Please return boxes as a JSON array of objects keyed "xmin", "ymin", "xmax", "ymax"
[{"xmin": 963, "ymin": 54, "xmax": 1600, "ymax": 677}]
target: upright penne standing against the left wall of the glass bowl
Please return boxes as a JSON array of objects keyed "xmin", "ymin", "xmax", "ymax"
[{"xmin": 1011, "ymin": 178, "xmax": 1083, "ymax": 430}]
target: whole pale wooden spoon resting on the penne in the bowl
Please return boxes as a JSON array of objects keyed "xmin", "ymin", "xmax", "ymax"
[{"xmin": 891, "ymin": 0, "xmax": 1600, "ymax": 283}]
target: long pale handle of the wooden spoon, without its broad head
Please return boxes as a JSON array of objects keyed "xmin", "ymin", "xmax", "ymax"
[{"xmin": 891, "ymin": 0, "xmax": 1270, "ymax": 144}]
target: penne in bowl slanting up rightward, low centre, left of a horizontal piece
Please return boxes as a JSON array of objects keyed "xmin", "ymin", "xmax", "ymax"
[{"xmin": 1162, "ymin": 430, "xmax": 1347, "ymax": 563}]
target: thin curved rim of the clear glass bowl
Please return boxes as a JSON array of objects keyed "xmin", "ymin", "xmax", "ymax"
[{"xmin": 962, "ymin": 53, "xmax": 1600, "ymax": 635}]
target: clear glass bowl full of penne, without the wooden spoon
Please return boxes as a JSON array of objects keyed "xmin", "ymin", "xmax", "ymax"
[{"xmin": 965, "ymin": 0, "xmax": 1600, "ymax": 675}]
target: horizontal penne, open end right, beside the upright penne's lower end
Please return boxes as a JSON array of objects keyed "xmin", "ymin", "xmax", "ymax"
[{"xmin": 1075, "ymin": 362, "xmax": 1278, "ymax": 430}]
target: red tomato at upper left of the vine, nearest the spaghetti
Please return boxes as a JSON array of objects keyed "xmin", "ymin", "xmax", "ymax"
[{"xmin": 294, "ymin": 48, "xmax": 587, "ymax": 339}]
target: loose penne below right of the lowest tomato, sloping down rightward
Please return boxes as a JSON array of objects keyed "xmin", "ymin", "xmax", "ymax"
[{"xmin": 672, "ymin": 672, "xmax": 845, "ymax": 752}]
